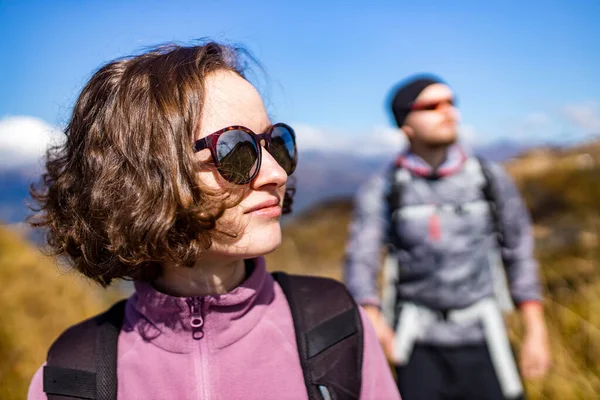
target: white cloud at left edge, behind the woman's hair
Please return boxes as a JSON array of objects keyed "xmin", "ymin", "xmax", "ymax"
[{"xmin": 0, "ymin": 116, "xmax": 61, "ymax": 167}]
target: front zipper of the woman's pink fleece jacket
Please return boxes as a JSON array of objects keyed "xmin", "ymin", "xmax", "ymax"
[{"xmin": 186, "ymin": 297, "xmax": 210, "ymax": 399}]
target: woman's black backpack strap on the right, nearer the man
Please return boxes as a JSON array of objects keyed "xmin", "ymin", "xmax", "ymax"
[{"xmin": 273, "ymin": 272, "xmax": 363, "ymax": 400}]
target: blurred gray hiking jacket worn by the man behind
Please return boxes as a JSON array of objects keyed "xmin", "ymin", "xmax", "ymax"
[{"xmin": 345, "ymin": 146, "xmax": 541, "ymax": 345}]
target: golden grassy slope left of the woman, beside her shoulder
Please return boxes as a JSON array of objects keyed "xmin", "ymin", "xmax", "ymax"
[{"xmin": 0, "ymin": 226, "xmax": 122, "ymax": 400}]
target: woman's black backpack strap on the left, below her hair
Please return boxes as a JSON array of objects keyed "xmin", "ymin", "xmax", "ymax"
[{"xmin": 44, "ymin": 300, "xmax": 127, "ymax": 400}]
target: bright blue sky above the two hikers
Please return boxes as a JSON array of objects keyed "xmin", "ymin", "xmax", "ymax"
[{"xmin": 0, "ymin": 0, "xmax": 600, "ymax": 162}]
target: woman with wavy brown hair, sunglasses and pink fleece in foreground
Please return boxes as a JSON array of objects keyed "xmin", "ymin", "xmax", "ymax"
[{"xmin": 29, "ymin": 43, "xmax": 399, "ymax": 399}]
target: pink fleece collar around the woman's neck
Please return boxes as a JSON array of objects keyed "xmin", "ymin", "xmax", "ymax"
[{"xmin": 125, "ymin": 257, "xmax": 274, "ymax": 353}]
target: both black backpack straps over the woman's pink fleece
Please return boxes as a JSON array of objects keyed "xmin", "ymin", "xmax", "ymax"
[{"xmin": 44, "ymin": 272, "xmax": 363, "ymax": 400}]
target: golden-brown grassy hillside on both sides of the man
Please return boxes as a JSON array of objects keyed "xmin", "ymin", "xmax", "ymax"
[{"xmin": 268, "ymin": 142, "xmax": 600, "ymax": 399}]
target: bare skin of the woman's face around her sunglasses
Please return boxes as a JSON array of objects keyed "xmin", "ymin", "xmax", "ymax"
[{"xmin": 196, "ymin": 70, "xmax": 287, "ymax": 260}]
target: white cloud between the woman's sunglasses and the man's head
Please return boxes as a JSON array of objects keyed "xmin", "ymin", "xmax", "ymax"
[{"xmin": 294, "ymin": 124, "xmax": 406, "ymax": 156}]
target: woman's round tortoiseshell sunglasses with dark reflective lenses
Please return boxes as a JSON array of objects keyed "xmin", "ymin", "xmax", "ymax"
[{"xmin": 194, "ymin": 123, "xmax": 298, "ymax": 185}]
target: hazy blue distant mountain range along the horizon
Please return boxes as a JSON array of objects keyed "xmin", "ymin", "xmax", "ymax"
[{"xmin": 0, "ymin": 141, "xmax": 528, "ymax": 224}]
